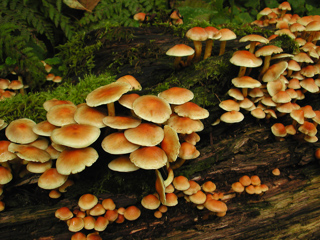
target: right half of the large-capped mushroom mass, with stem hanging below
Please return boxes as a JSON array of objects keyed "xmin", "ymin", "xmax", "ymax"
[{"xmin": 101, "ymin": 87, "xmax": 209, "ymax": 204}]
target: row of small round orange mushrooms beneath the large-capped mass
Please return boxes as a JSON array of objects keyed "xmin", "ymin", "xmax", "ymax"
[{"xmin": 55, "ymin": 173, "xmax": 230, "ymax": 239}]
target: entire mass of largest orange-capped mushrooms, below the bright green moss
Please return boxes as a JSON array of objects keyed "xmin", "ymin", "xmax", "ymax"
[{"xmin": 0, "ymin": 75, "xmax": 209, "ymax": 212}]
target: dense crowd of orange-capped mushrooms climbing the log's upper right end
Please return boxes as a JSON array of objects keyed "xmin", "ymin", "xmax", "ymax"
[{"xmin": 214, "ymin": 3, "xmax": 320, "ymax": 142}]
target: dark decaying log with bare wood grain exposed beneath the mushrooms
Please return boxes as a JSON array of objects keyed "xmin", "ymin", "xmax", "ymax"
[{"xmin": 0, "ymin": 26, "xmax": 320, "ymax": 240}]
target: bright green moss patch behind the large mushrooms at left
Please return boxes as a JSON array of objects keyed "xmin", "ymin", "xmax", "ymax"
[{"xmin": 0, "ymin": 73, "xmax": 115, "ymax": 123}]
